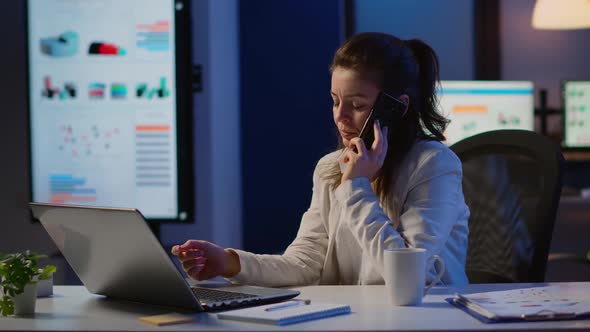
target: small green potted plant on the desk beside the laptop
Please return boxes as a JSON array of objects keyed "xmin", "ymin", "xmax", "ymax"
[{"xmin": 0, "ymin": 250, "xmax": 56, "ymax": 316}]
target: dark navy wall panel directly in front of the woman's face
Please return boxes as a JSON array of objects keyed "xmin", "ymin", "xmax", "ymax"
[{"xmin": 240, "ymin": 0, "xmax": 343, "ymax": 253}]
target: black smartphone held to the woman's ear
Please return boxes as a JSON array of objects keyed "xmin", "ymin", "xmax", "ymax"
[{"xmin": 359, "ymin": 91, "xmax": 407, "ymax": 150}]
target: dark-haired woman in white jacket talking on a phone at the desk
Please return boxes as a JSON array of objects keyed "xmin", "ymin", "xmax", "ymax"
[{"xmin": 172, "ymin": 33, "xmax": 469, "ymax": 286}]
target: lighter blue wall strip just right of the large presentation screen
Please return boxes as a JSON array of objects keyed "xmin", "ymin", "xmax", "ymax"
[{"xmin": 160, "ymin": 0, "xmax": 242, "ymax": 248}]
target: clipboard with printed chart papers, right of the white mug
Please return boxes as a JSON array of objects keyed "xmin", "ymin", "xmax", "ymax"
[{"xmin": 446, "ymin": 285, "xmax": 590, "ymax": 323}]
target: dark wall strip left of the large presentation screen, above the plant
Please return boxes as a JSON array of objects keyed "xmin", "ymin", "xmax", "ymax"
[{"xmin": 0, "ymin": 0, "xmax": 73, "ymax": 281}]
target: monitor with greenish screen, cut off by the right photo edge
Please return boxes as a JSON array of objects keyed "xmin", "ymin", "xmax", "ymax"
[{"xmin": 562, "ymin": 81, "xmax": 590, "ymax": 149}]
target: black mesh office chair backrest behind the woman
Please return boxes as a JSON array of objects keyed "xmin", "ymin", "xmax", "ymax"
[{"xmin": 451, "ymin": 130, "xmax": 564, "ymax": 283}]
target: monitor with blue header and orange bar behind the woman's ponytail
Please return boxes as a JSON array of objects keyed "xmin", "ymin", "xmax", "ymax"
[{"xmin": 438, "ymin": 80, "xmax": 535, "ymax": 145}]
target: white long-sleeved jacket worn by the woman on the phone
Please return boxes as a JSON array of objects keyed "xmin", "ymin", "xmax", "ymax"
[{"xmin": 231, "ymin": 141, "xmax": 469, "ymax": 286}]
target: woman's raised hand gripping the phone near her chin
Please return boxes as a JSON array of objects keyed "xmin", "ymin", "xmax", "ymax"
[{"xmin": 341, "ymin": 121, "xmax": 389, "ymax": 183}]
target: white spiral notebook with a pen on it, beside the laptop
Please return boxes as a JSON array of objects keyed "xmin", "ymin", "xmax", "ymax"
[{"xmin": 217, "ymin": 301, "xmax": 350, "ymax": 325}]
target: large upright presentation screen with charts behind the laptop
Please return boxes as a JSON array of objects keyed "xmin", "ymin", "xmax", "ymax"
[{"xmin": 26, "ymin": 0, "xmax": 194, "ymax": 222}]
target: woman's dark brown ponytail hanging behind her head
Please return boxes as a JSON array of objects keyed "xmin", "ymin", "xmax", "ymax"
[{"xmin": 405, "ymin": 39, "xmax": 449, "ymax": 141}]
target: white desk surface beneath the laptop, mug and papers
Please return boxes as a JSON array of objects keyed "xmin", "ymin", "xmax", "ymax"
[{"xmin": 0, "ymin": 282, "xmax": 590, "ymax": 331}]
